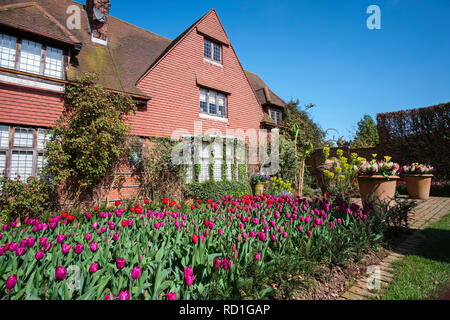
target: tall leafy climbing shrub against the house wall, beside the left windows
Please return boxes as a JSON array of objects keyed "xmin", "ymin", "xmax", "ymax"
[{"xmin": 44, "ymin": 74, "xmax": 135, "ymax": 203}]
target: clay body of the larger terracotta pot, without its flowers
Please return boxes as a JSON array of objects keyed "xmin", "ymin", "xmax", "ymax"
[{"xmin": 358, "ymin": 175, "xmax": 400, "ymax": 202}]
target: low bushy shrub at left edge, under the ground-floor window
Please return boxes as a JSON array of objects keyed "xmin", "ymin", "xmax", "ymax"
[{"xmin": 0, "ymin": 177, "xmax": 53, "ymax": 223}]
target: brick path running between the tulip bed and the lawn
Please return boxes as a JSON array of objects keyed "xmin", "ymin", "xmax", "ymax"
[{"xmin": 338, "ymin": 197, "xmax": 450, "ymax": 300}]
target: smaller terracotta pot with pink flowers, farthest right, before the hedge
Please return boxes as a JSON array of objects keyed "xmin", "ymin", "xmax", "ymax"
[{"xmin": 402, "ymin": 163, "xmax": 435, "ymax": 200}]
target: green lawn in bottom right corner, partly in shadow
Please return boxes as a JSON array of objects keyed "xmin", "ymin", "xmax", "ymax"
[{"xmin": 381, "ymin": 214, "xmax": 450, "ymax": 300}]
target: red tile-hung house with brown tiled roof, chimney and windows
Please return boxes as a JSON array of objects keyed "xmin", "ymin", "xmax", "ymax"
[{"xmin": 0, "ymin": 0, "xmax": 286, "ymax": 200}]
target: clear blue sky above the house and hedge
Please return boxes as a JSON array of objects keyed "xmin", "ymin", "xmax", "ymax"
[{"xmin": 85, "ymin": 0, "xmax": 450, "ymax": 142}]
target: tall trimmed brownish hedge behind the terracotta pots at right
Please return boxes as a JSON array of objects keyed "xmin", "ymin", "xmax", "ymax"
[{"xmin": 377, "ymin": 102, "xmax": 450, "ymax": 180}]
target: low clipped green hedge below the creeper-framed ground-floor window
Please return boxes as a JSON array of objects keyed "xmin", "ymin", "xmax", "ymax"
[{"xmin": 185, "ymin": 180, "xmax": 252, "ymax": 201}]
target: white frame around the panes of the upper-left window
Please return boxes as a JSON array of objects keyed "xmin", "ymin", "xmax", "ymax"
[{"xmin": 0, "ymin": 31, "xmax": 67, "ymax": 80}]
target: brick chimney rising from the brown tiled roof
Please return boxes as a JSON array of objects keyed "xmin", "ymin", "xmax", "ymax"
[{"xmin": 86, "ymin": 0, "xmax": 111, "ymax": 41}]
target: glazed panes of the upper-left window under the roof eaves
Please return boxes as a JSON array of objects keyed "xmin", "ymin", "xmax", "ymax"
[{"xmin": 0, "ymin": 33, "xmax": 63, "ymax": 79}]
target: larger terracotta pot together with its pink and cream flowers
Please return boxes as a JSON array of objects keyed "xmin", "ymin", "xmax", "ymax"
[{"xmin": 358, "ymin": 155, "xmax": 400, "ymax": 202}]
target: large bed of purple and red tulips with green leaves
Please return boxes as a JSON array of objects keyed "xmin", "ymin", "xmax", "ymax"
[{"xmin": 0, "ymin": 195, "xmax": 381, "ymax": 300}]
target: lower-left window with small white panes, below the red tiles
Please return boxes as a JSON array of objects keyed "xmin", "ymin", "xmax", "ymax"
[{"xmin": 0, "ymin": 125, "xmax": 50, "ymax": 181}]
